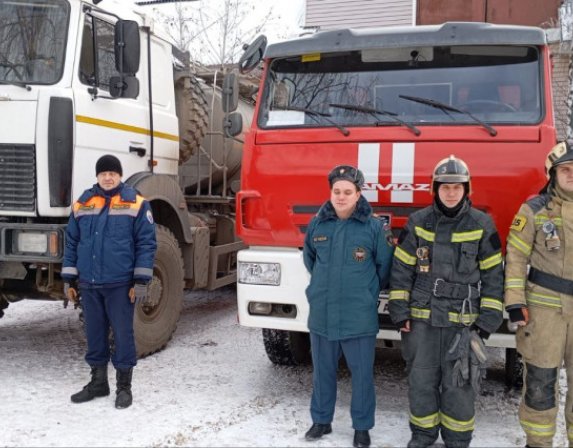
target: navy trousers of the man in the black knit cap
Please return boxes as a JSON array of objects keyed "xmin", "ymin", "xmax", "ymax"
[{"xmin": 80, "ymin": 285, "xmax": 137, "ymax": 369}]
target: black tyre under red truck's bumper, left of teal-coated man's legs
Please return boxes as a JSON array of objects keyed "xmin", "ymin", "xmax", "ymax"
[{"xmin": 263, "ymin": 328, "xmax": 311, "ymax": 366}]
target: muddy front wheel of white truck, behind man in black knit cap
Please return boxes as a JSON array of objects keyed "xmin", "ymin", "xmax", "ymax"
[{"xmin": 133, "ymin": 225, "xmax": 184, "ymax": 357}]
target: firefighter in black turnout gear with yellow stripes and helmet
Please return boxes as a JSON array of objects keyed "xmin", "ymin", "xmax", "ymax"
[{"xmin": 389, "ymin": 156, "xmax": 503, "ymax": 448}]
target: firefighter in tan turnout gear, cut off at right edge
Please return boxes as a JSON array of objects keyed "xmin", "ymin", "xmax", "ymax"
[{"xmin": 505, "ymin": 142, "xmax": 573, "ymax": 447}]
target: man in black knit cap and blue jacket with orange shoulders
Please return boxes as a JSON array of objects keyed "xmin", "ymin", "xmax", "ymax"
[{"xmin": 62, "ymin": 155, "xmax": 157, "ymax": 409}]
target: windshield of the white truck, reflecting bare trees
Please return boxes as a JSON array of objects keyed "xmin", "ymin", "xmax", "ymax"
[{"xmin": 0, "ymin": 0, "xmax": 70, "ymax": 86}]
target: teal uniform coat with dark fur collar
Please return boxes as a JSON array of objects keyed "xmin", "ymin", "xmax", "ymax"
[{"xmin": 303, "ymin": 196, "xmax": 393, "ymax": 340}]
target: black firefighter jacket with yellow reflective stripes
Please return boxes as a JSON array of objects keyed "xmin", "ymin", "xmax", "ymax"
[{"xmin": 388, "ymin": 200, "xmax": 503, "ymax": 333}]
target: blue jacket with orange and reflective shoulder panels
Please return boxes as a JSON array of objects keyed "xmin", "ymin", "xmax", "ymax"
[{"xmin": 62, "ymin": 183, "xmax": 157, "ymax": 287}]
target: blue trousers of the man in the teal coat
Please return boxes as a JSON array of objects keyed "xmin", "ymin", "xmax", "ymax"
[{"xmin": 310, "ymin": 333, "xmax": 376, "ymax": 430}]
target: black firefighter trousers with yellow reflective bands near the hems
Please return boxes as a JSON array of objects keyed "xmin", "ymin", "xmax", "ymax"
[{"xmin": 402, "ymin": 321, "xmax": 475, "ymax": 447}]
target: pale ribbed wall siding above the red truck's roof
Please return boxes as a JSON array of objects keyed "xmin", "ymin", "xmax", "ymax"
[{"xmin": 305, "ymin": 0, "xmax": 415, "ymax": 30}]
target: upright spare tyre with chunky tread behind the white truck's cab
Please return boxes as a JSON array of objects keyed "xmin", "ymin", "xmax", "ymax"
[{"xmin": 175, "ymin": 75, "xmax": 209, "ymax": 165}]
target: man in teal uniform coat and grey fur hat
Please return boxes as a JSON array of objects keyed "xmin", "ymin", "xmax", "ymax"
[{"xmin": 303, "ymin": 165, "xmax": 394, "ymax": 448}]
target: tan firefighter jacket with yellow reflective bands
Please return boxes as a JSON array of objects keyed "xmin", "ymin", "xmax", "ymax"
[{"xmin": 505, "ymin": 194, "xmax": 573, "ymax": 312}]
